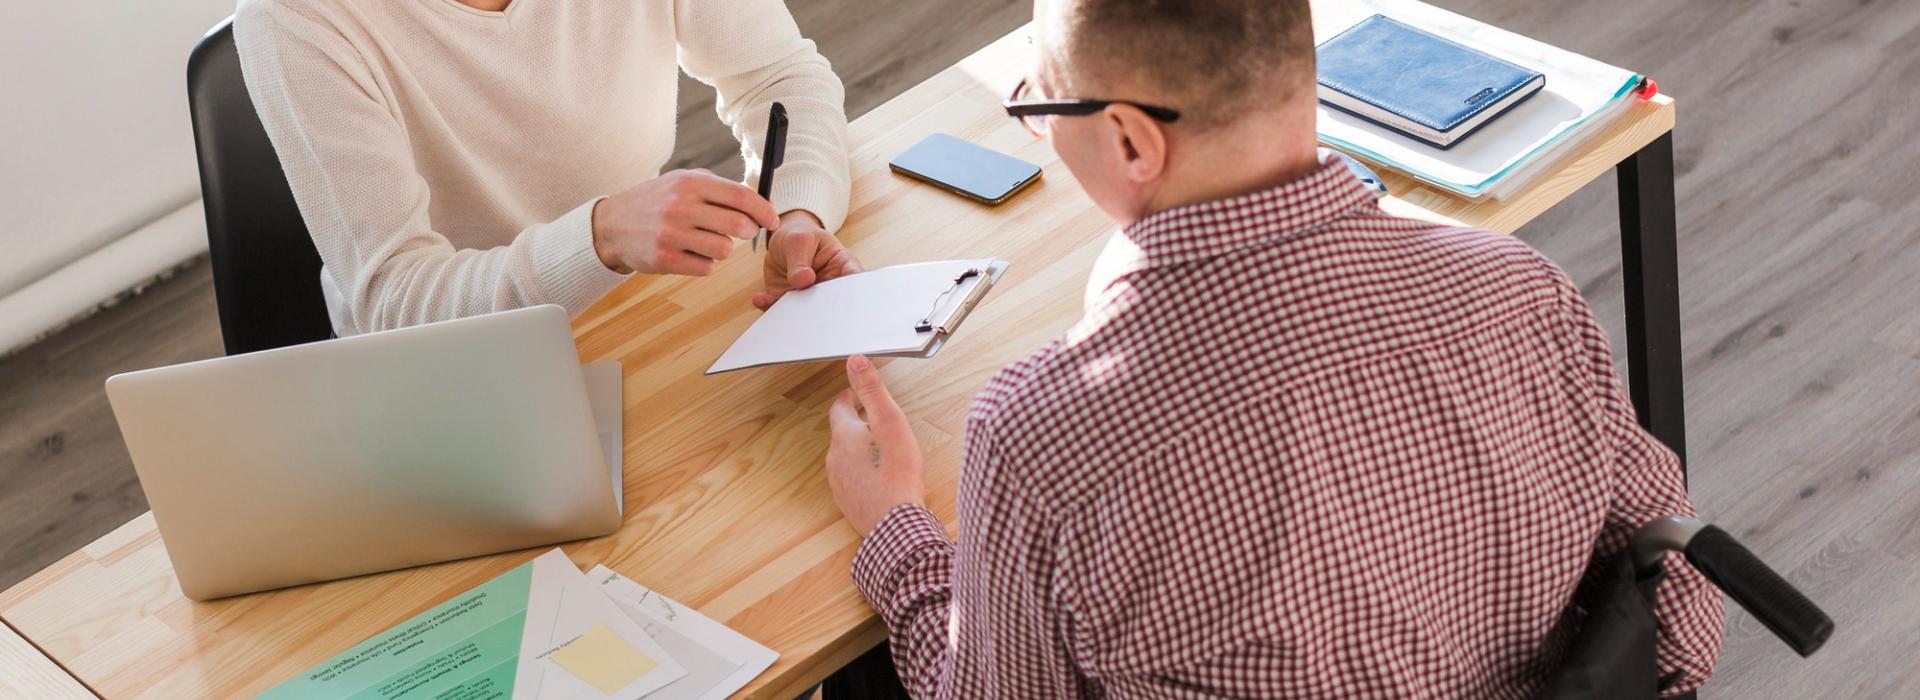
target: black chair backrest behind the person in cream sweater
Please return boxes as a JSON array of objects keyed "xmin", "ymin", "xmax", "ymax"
[{"xmin": 186, "ymin": 19, "xmax": 332, "ymax": 355}]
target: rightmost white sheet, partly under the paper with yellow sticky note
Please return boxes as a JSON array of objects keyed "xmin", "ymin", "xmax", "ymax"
[{"xmin": 588, "ymin": 566, "xmax": 780, "ymax": 700}]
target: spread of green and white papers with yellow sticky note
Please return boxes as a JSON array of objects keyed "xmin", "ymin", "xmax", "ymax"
[{"xmin": 261, "ymin": 548, "xmax": 778, "ymax": 700}]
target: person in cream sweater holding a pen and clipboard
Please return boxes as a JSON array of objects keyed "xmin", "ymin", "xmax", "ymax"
[{"xmin": 234, "ymin": 0, "xmax": 858, "ymax": 336}]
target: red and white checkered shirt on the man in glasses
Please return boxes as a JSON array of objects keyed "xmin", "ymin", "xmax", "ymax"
[{"xmin": 852, "ymin": 159, "xmax": 1722, "ymax": 698}]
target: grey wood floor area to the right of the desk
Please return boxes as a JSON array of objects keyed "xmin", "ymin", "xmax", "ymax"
[{"xmin": 1440, "ymin": 0, "xmax": 1920, "ymax": 698}]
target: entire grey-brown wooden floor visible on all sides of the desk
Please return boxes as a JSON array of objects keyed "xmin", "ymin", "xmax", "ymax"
[{"xmin": 0, "ymin": 0, "xmax": 1920, "ymax": 698}]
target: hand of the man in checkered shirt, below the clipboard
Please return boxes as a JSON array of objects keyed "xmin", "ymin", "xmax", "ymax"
[{"xmin": 828, "ymin": 355, "xmax": 927, "ymax": 537}]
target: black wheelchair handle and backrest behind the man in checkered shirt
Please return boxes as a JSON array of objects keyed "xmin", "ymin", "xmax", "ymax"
[{"xmin": 1542, "ymin": 516, "xmax": 1834, "ymax": 700}]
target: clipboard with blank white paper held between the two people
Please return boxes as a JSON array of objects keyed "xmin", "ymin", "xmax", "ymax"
[{"xmin": 707, "ymin": 259, "xmax": 1006, "ymax": 374}]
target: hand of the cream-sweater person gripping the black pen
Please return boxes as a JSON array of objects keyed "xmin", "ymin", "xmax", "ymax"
[{"xmin": 593, "ymin": 171, "xmax": 780, "ymax": 276}]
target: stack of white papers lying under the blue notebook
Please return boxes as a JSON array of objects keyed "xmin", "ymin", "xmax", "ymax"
[{"xmin": 1313, "ymin": 0, "xmax": 1640, "ymax": 198}]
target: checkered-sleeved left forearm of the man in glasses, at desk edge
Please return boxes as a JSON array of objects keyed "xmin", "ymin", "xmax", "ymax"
[{"xmin": 852, "ymin": 504, "xmax": 954, "ymax": 698}]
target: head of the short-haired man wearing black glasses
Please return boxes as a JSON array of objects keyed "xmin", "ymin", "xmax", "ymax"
[{"xmin": 1029, "ymin": 0, "xmax": 1315, "ymax": 224}]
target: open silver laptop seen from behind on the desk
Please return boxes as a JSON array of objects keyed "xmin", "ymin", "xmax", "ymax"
[{"xmin": 108, "ymin": 307, "xmax": 620, "ymax": 600}]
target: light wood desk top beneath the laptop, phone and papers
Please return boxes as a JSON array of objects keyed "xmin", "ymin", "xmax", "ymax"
[{"xmin": 0, "ymin": 21, "xmax": 1674, "ymax": 700}]
